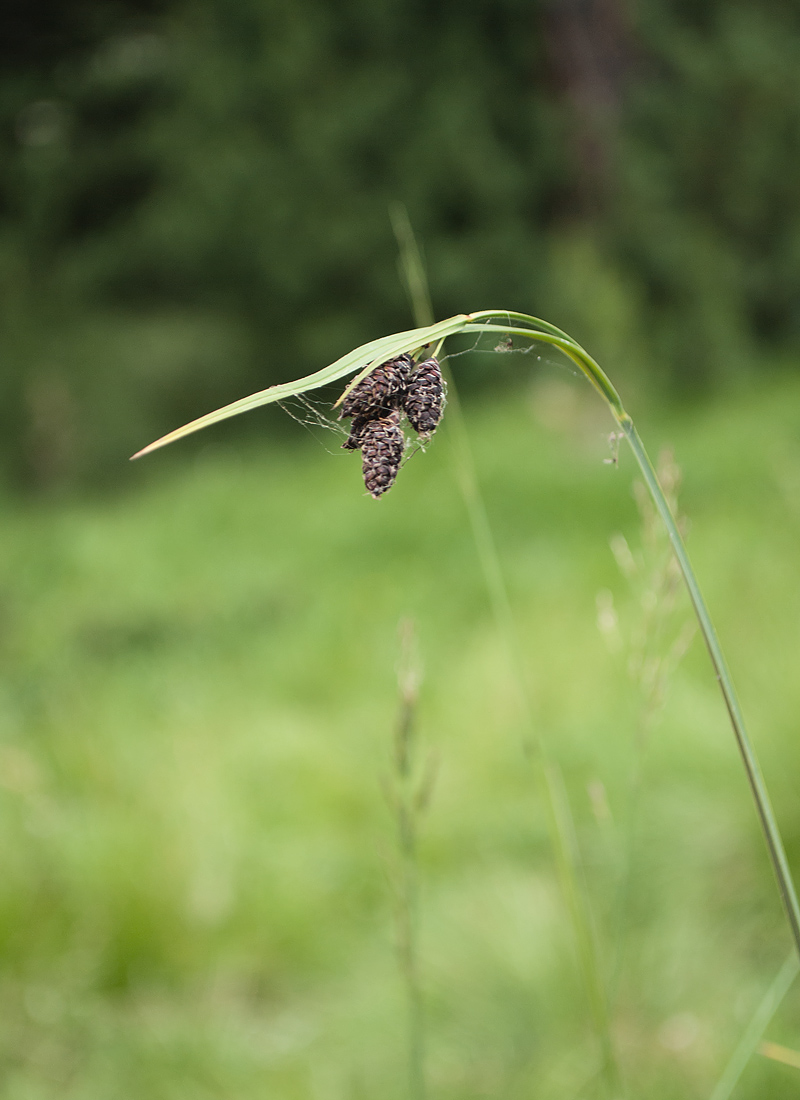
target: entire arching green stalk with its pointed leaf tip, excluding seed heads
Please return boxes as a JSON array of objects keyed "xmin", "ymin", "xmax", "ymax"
[{"xmin": 133, "ymin": 309, "xmax": 800, "ymax": 956}]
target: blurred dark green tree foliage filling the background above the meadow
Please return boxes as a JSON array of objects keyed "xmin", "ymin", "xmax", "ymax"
[{"xmin": 0, "ymin": 0, "xmax": 800, "ymax": 484}]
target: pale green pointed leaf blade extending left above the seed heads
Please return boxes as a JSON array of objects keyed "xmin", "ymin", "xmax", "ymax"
[{"xmin": 132, "ymin": 315, "xmax": 467, "ymax": 459}]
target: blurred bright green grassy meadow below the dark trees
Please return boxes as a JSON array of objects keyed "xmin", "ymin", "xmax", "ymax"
[{"xmin": 0, "ymin": 373, "xmax": 800, "ymax": 1100}]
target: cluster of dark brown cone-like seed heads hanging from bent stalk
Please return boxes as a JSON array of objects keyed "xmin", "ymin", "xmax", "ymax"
[{"xmin": 339, "ymin": 355, "xmax": 445, "ymax": 499}]
